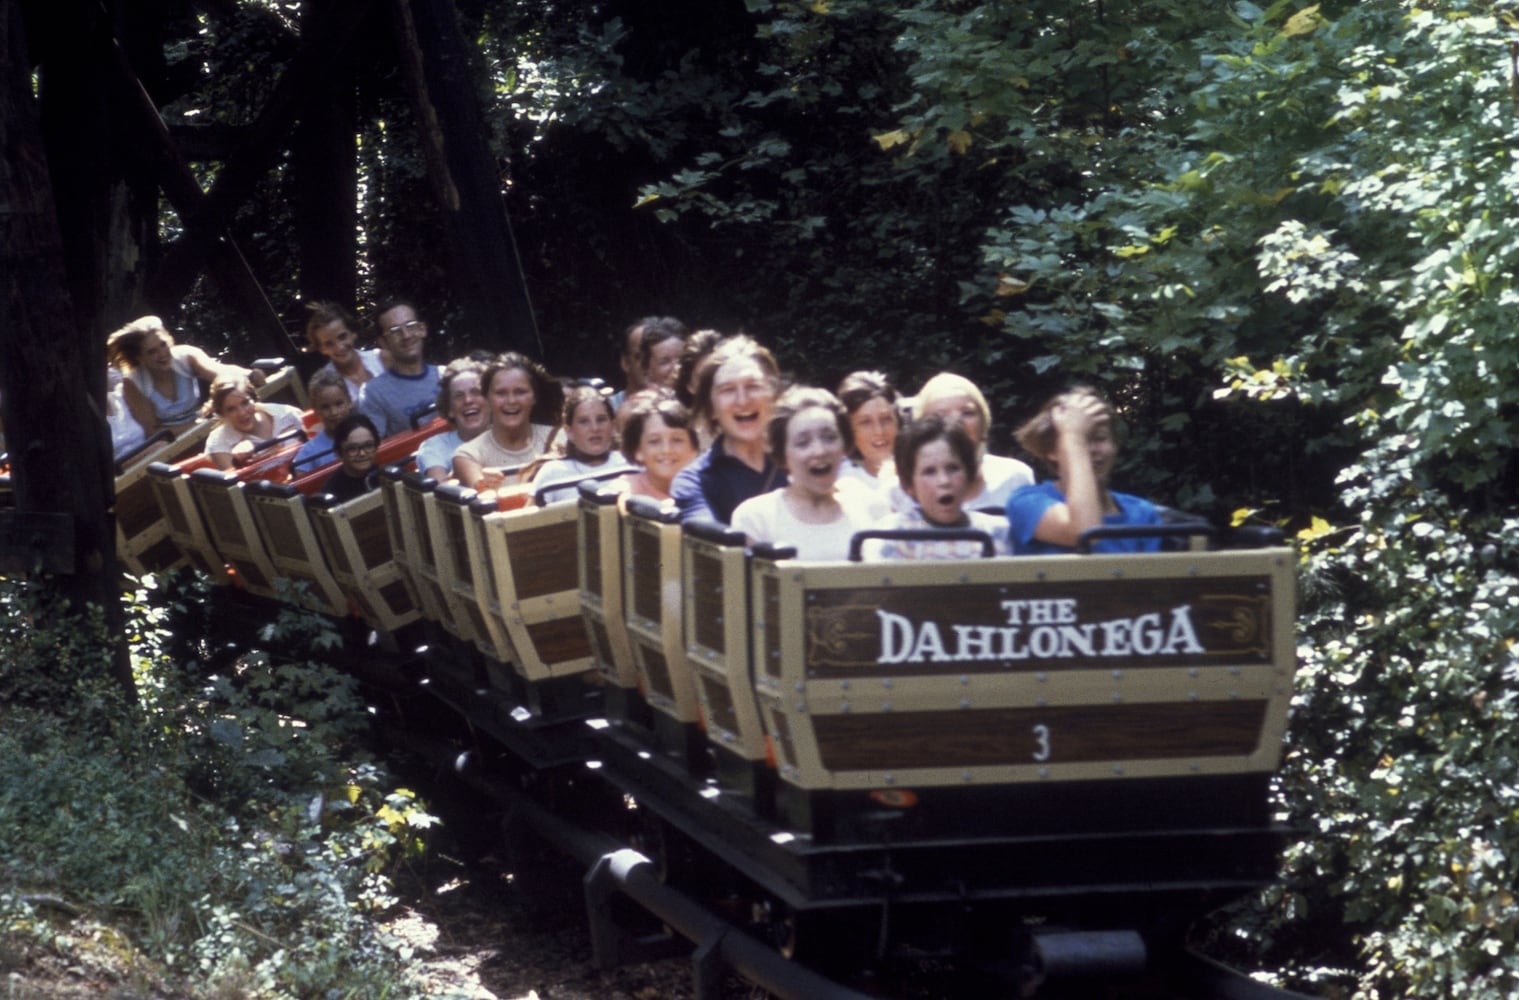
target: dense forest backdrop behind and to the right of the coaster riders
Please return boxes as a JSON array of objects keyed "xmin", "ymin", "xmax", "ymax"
[{"xmin": 2, "ymin": 0, "xmax": 1519, "ymax": 997}]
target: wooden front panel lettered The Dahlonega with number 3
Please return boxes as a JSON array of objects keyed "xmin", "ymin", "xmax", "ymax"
[{"xmin": 752, "ymin": 549, "xmax": 1296, "ymax": 789}]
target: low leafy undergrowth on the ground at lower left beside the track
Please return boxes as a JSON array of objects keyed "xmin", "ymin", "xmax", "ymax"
[{"xmin": 0, "ymin": 577, "xmax": 434, "ymax": 997}]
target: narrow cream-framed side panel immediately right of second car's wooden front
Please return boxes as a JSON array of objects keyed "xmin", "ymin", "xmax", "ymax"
[{"xmin": 577, "ymin": 483, "xmax": 638, "ymax": 691}]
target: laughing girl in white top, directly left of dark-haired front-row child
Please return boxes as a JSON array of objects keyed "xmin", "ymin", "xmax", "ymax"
[{"xmin": 732, "ymin": 388, "xmax": 889, "ymax": 559}]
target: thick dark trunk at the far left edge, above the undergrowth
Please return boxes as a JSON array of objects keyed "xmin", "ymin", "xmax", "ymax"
[{"xmin": 0, "ymin": 0, "xmax": 132, "ymax": 691}]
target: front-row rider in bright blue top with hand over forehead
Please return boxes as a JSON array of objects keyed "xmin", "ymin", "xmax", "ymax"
[{"xmin": 1007, "ymin": 386, "xmax": 1161, "ymax": 555}]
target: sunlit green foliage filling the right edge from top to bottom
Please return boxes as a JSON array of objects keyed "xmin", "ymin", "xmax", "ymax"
[{"xmin": 986, "ymin": 3, "xmax": 1519, "ymax": 997}]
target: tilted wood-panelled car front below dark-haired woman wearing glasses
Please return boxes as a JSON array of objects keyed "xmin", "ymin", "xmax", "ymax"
[{"xmin": 305, "ymin": 489, "xmax": 421, "ymax": 632}]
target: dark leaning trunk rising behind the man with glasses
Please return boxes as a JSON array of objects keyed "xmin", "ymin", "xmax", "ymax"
[{"xmin": 390, "ymin": 0, "xmax": 544, "ymax": 359}]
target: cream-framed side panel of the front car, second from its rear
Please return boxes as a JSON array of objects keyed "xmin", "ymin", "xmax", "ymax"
[{"xmin": 623, "ymin": 497, "xmax": 700, "ymax": 725}]
